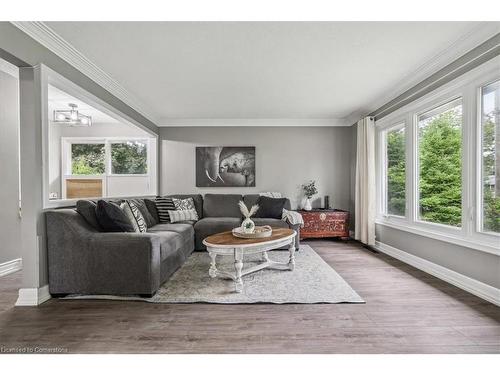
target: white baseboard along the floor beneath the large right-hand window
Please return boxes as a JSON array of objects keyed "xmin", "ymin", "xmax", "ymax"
[{"xmin": 375, "ymin": 241, "xmax": 500, "ymax": 306}]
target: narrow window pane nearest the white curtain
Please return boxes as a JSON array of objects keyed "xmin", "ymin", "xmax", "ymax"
[{"xmin": 385, "ymin": 124, "xmax": 406, "ymax": 216}]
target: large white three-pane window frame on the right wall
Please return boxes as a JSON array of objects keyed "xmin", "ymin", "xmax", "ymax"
[{"xmin": 376, "ymin": 57, "xmax": 500, "ymax": 255}]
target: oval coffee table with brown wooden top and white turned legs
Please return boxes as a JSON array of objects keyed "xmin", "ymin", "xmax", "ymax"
[{"xmin": 203, "ymin": 228, "xmax": 297, "ymax": 293}]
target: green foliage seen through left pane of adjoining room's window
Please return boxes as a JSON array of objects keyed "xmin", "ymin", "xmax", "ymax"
[{"xmin": 71, "ymin": 143, "xmax": 105, "ymax": 175}]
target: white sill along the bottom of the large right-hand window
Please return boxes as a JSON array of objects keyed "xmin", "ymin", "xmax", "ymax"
[{"xmin": 375, "ymin": 218, "xmax": 500, "ymax": 256}]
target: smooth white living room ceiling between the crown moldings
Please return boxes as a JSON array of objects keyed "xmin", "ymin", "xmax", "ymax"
[{"xmin": 45, "ymin": 22, "xmax": 498, "ymax": 125}]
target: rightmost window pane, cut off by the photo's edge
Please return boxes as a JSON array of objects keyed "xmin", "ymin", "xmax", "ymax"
[{"xmin": 480, "ymin": 81, "xmax": 500, "ymax": 233}]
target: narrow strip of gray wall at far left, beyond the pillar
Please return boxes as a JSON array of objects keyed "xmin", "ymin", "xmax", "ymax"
[{"xmin": 0, "ymin": 70, "xmax": 21, "ymax": 264}]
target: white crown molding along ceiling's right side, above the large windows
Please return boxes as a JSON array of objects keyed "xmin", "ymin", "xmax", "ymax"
[{"xmin": 346, "ymin": 22, "xmax": 500, "ymax": 125}]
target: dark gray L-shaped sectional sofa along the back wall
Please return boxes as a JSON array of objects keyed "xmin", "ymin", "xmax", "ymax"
[{"xmin": 46, "ymin": 194, "xmax": 299, "ymax": 297}]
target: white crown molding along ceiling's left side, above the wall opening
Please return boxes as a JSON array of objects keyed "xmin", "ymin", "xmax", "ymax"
[{"xmin": 11, "ymin": 21, "xmax": 158, "ymax": 124}]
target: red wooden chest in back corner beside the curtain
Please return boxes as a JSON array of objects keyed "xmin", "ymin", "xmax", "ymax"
[{"xmin": 299, "ymin": 209, "xmax": 349, "ymax": 240}]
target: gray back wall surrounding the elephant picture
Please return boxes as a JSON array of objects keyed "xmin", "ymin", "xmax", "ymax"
[{"xmin": 160, "ymin": 127, "xmax": 353, "ymax": 209}]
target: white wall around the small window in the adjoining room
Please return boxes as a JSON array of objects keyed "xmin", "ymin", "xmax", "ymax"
[{"xmin": 49, "ymin": 122, "xmax": 156, "ymax": 197}]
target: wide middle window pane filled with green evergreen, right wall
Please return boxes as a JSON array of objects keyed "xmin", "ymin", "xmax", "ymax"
[{"xmin": 418, "ymin": 99, "xmax": 462, "ymax": 227}]
